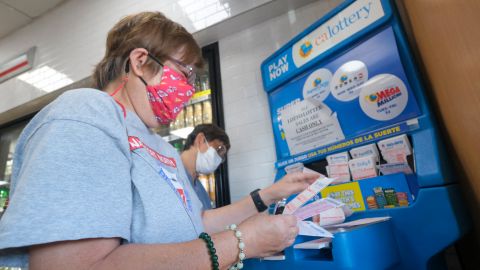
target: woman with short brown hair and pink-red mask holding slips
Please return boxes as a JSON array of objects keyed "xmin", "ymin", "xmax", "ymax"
[{"xmin": 0, "ymin": 12, "xmax": 317, "ymax": 270}]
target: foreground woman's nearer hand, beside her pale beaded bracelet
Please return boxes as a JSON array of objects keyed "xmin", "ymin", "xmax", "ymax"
[{"xmin": 239, "ymin": 214, "xmax": 298, "ymax": 258}]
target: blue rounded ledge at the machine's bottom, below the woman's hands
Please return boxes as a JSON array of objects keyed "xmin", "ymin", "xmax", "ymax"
[{"xmin": 260, "ymin": 220, "xmax": 400, "ymax": 269}]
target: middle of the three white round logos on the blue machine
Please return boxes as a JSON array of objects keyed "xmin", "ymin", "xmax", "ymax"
[{"xmin": 331, "ymin": 60, "xmax": 368, "ymax": 102}]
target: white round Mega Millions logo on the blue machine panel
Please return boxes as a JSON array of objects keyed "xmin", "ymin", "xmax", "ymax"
[{"xmin": 359, "ymin": 74, "xmax": 408, "ymax": 121}]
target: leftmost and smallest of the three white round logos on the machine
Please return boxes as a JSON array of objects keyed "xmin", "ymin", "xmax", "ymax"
[{"xmin": 303, "ymin": 68, "xmax": 332, "ymax": 102}]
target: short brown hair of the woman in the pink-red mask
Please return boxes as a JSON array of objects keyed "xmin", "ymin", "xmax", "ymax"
[{"xmin": 93, "ymin": 12, "xmax": 203, "ymax": 90}]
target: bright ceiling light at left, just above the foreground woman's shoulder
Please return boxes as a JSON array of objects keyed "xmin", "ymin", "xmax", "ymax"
[{"xmin": 18, "ymin": 66, "xmax": 73, "ymax": 92}]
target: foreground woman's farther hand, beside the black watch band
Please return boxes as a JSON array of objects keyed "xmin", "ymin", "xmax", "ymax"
[{"xmin": 260, "ymin": 172, "xmax": 321, "ymax": 205}]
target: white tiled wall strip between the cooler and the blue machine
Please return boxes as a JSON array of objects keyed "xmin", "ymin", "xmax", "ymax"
[{"xmin": 219, "ymin": 0, "xmax": 342, "ymax": 201}]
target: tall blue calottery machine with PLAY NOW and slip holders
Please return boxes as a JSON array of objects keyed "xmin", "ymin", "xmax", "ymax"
[{"xmin": 246, "ymin": 0, "xmax": 470, "ymax": 269}]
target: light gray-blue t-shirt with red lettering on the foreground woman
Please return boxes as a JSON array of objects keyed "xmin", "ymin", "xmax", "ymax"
[{"xmin": 0, "ymin": 89, "xmax": 203, "ymax": 267}]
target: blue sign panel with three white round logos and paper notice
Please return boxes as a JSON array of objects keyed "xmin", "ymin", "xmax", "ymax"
[{"xmin": 269, "ymin": 27, "xmax": 420, "ymax": 160}]
